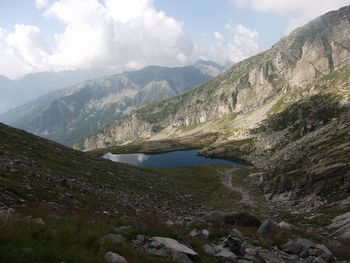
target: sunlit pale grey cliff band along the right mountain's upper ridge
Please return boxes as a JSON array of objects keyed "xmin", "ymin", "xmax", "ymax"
[{"xmin": 80, "ymin": 7, "xmax": 350, "ymax": 150}]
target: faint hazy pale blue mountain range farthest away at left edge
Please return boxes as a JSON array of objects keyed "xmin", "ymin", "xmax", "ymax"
[{"xmin": 0, "ymin": 69, "xmax": 115, "ymax": 113}]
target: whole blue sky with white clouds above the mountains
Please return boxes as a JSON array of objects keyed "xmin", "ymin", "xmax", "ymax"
[{"xmin": 0, "ymin": 0, "xmax": 350, "ymax": 79}]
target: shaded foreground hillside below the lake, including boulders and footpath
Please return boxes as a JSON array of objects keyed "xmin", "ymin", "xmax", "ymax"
[{"xmin": 0, "ymin": 124, "xmax": 349, "ymax": 263}]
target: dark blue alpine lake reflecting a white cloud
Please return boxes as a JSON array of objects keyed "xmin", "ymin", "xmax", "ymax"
[{"xmin": 103, "ymin": 150, "xmax": 242, "ymax": 168}]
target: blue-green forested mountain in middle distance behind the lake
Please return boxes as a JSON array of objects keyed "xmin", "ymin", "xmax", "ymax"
[{"xmin": 0, "ymin": 61, "xmax": 222, "ymax": 145}]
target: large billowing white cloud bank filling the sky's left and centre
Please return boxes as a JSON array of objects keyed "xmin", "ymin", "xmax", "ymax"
[{"xmin": 0, "ymin": 0, "xmax": 259, "ymax": 78}]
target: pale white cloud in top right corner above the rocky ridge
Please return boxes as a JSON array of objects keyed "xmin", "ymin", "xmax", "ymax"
[{"xmin": 230, "ymin": 0, "xmax": 350, "ymax": 32}]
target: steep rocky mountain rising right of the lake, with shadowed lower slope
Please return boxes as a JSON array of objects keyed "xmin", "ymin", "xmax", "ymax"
[{"xmin": 80, "ymin": 6, "xmax": 350, "ymax": 198}]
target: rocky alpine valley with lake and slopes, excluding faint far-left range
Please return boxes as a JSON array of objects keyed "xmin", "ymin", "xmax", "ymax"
[{"xmin": 0, "ymin": 3, "xmax": 350, "ymax": 263}]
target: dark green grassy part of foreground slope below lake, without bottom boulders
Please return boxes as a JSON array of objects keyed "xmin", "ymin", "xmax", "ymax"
[{"xmin": 0, "ymin": 124, "xmax": 258, "ymax": 263}]
